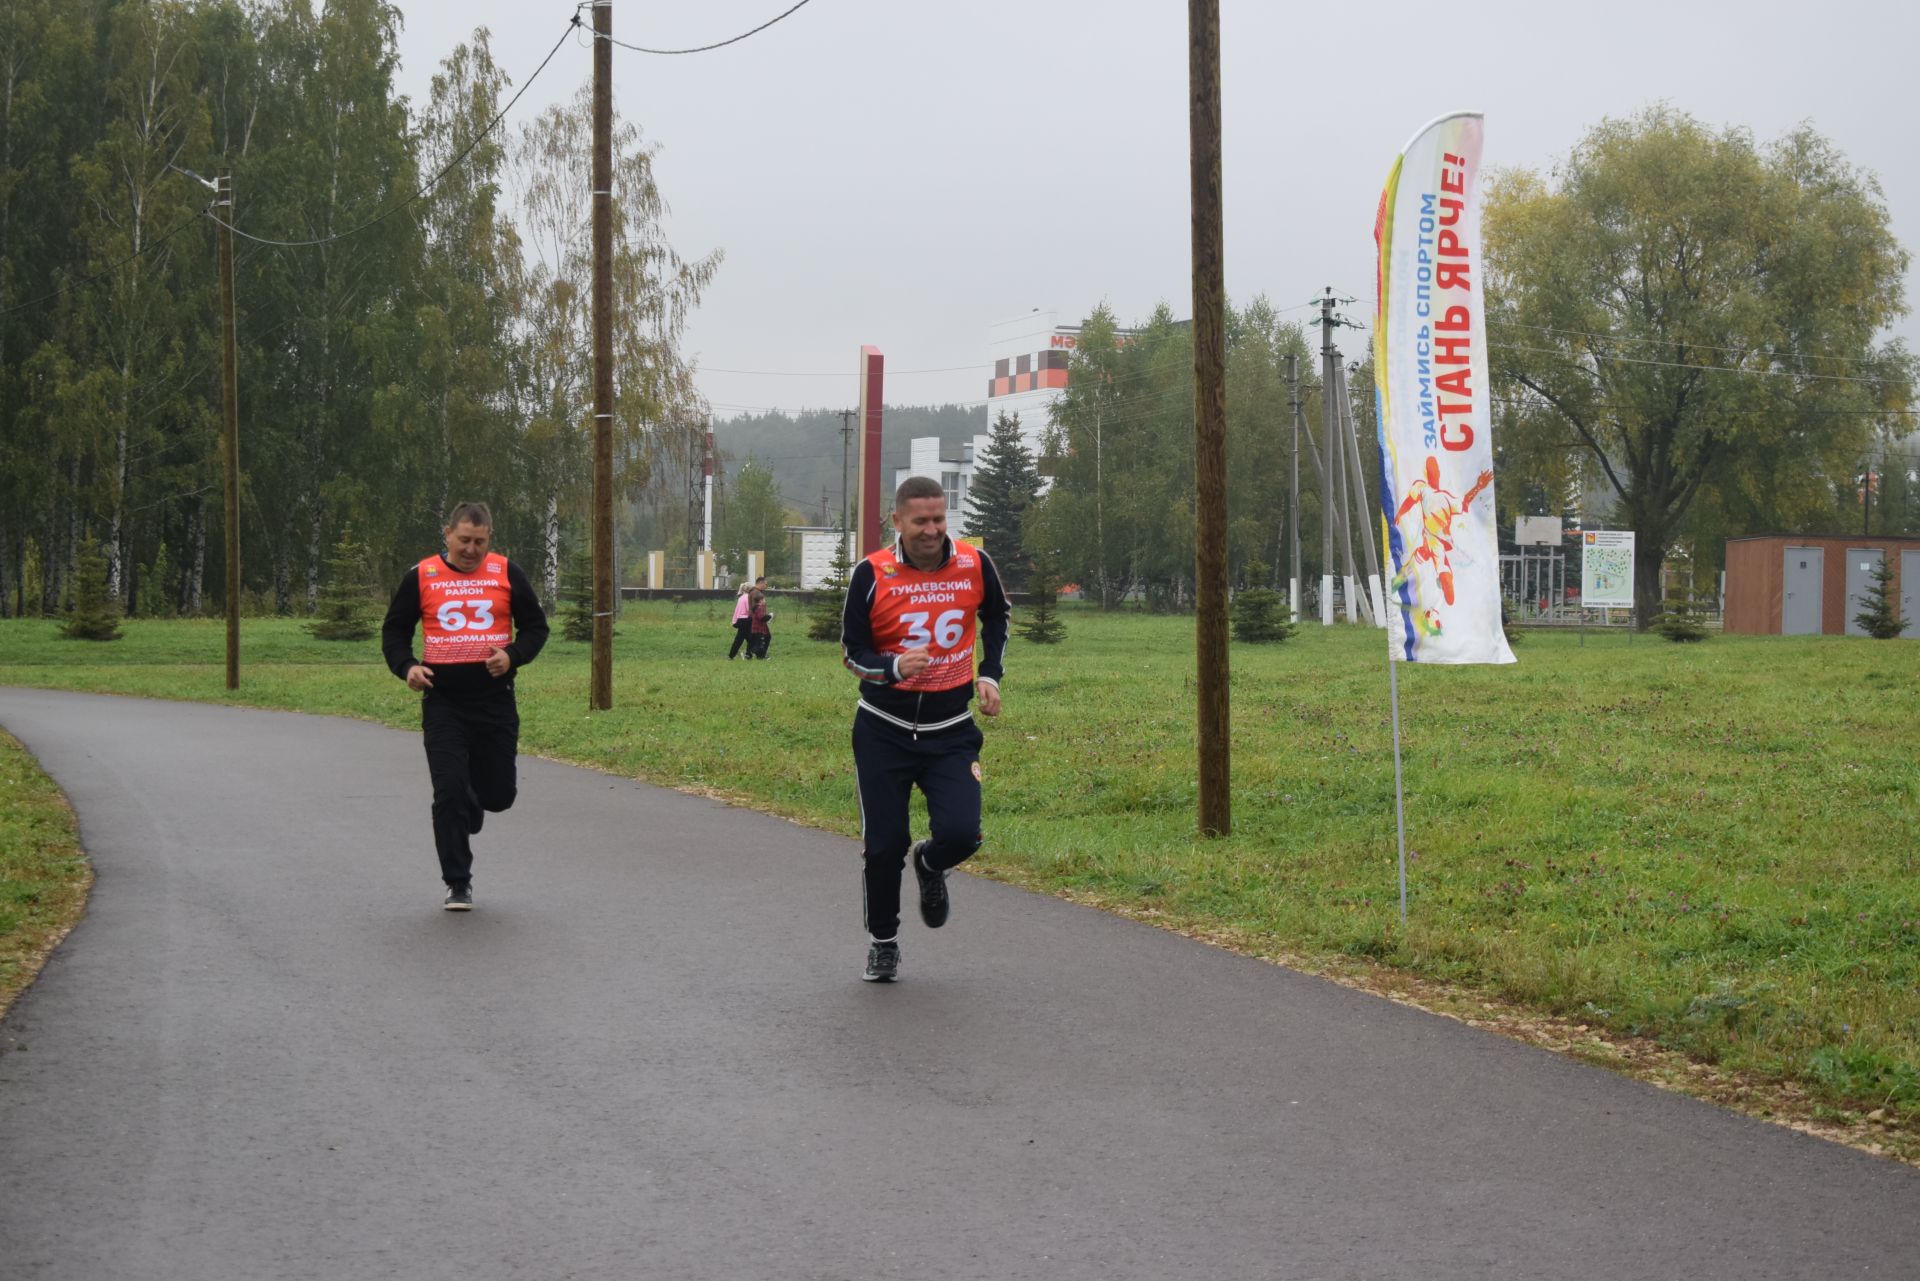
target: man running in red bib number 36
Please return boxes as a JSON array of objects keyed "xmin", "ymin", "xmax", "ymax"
[{"xmin": 841, "ymin": 476, "xmax": 1012, "ymax": 983}]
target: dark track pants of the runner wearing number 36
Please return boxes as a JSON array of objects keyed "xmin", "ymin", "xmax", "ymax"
[{"xmin": 852, "ymin": 711, "xmax": 985, "ymax": 939}]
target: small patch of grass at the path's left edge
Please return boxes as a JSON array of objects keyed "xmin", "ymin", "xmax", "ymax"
[{"xmin": 0, "ymin": 734, "xmax": 92, "ymax": 1014}]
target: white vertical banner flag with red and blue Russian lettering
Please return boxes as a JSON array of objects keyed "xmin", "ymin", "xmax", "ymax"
[{"xmin": 1373, "ymin": 111, "xmax": 1513, "ymax": 663}]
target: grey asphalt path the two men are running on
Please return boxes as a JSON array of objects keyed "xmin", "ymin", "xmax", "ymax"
[{"xmin": 0, "ymin": 689, "xmax": 1920, "ymax": 1281}]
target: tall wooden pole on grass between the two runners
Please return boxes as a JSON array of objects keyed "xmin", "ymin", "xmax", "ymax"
[{"xmin": 589, "ymin": 0, "xmax": 614, "ymax": 711}]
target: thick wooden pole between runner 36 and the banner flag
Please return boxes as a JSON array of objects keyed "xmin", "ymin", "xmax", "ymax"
[{"xmin": 1187, "ymin": 0, "xmax": 1233, "ymax": 835}]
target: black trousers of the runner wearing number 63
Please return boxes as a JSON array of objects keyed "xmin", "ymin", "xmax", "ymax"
[{"xmin": 420, "ymin": 688, "xmax": 520, "ymax": 885}]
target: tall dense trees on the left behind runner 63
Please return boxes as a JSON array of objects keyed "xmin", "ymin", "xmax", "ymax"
[{"xmin": 0, "ymin": 0, "xmax": 718, "ymax": 615}]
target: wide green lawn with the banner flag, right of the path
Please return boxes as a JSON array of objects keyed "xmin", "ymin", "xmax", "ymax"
[{"xmin": 0, "ymin": 603, "xmax": 1920, "ymax": 1154}]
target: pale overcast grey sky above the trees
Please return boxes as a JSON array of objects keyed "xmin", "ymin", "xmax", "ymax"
[{"xmin": 389, "ymin": 0, "xmax": 1920, "ymax": 417}]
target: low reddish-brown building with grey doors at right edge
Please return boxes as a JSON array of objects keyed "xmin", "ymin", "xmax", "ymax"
[{"xmin": 1724, "ymin": 534, "xmax": 1920, "ymax": 636}]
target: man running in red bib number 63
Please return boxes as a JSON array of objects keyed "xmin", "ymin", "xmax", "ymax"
[{"xmin": 380, "ymin": 503, "xmax": 547, "ymax": 912}]
